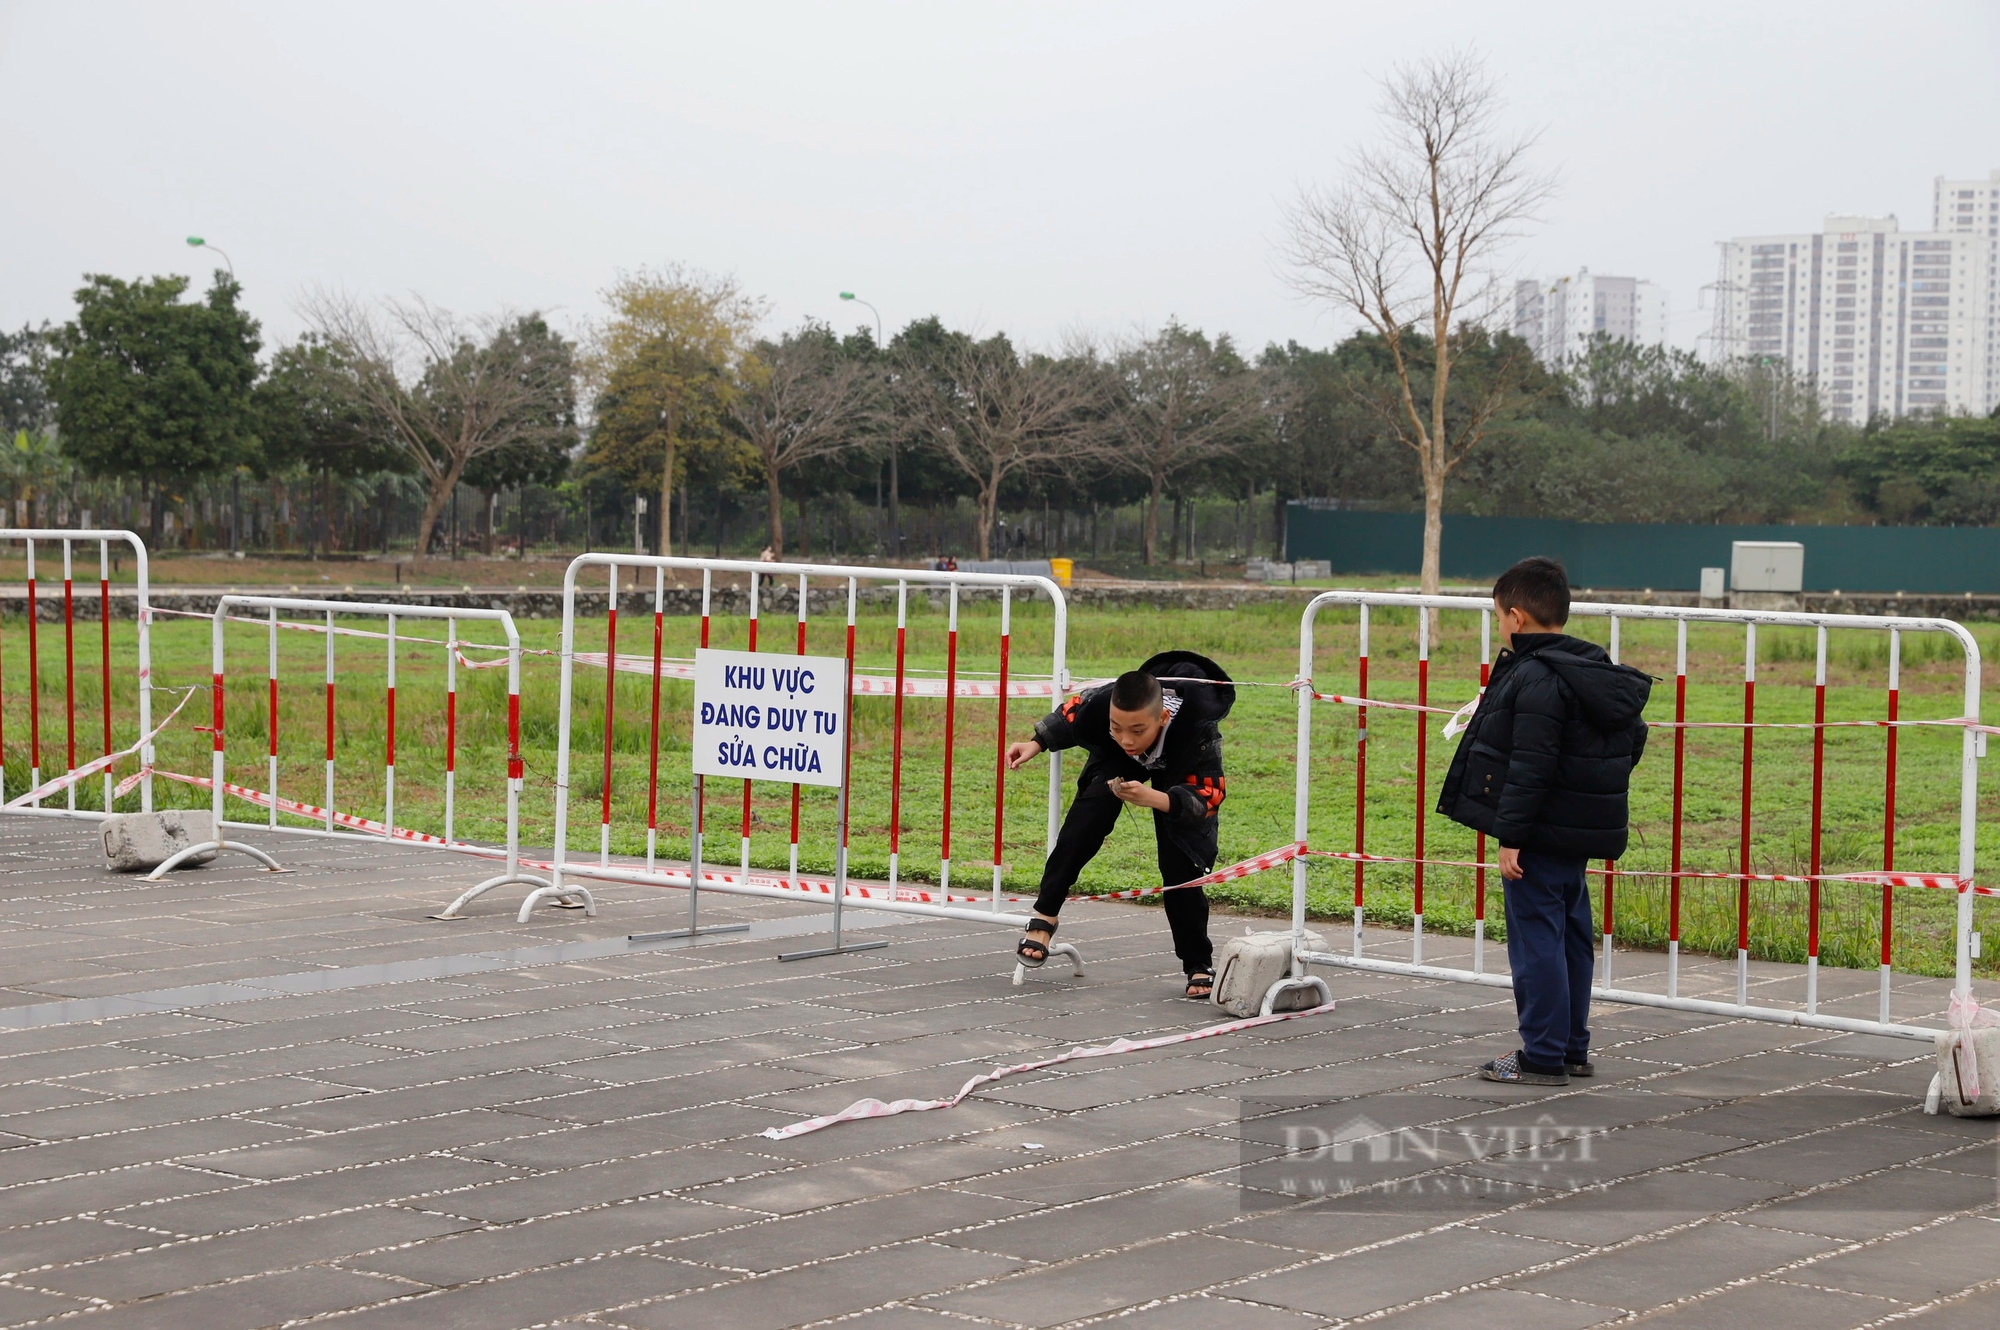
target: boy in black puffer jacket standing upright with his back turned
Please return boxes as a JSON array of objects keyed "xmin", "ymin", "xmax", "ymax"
[{"xmin": 1438, "ymin": 558, "xmax": 1652, "ymax": 1086}]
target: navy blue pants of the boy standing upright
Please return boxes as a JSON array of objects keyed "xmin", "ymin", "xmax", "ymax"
[{"xmin": 1502, "ymin": 850, "xmax": 1598, "ymax": 1072}]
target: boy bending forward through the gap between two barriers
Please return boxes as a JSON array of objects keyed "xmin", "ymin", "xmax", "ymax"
[{"xmin": 1006, "ymin": 652, "xmax": 1236, "ymax": 998}]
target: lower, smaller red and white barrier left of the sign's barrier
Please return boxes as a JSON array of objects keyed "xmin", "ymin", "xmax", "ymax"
[{"xmin": 146, "ymin": 594, "xmax": 556, "ymax": 918}]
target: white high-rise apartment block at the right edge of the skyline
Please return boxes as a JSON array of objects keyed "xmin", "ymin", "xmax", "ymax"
[{"xmin": 1714, "ymin": 172, "xmax": 2000, "ymax": 424}]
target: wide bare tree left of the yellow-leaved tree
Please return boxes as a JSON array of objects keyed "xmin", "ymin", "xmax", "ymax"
[{"xmin": 300, "ymin": 292, "xmax": 576, "ymax": 560}]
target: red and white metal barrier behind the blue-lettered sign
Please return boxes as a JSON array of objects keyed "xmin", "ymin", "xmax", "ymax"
[{"xmin": 500, "ymin": 554, "xmax": 1070, "ymax": 948}]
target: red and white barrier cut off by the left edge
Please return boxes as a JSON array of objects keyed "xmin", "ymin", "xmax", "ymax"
[{"xmin": 0, "ymin": 526, "xmax": 156, "ymax": 818}]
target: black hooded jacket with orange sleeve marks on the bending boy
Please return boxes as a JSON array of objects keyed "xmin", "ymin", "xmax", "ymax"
[{"xmin": 1034, "ymin": 652, "xmax": 1236, "ymax": 822}]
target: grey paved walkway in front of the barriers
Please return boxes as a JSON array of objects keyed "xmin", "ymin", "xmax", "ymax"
[{"xmin": 0, "ymin": 818, "xmax": 2000, "ymax": 1330}]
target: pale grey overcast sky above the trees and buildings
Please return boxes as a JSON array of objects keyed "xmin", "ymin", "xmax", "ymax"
[{"xmin": 0, "ymin": 0, "xmax": 2000, "ymax": 358}]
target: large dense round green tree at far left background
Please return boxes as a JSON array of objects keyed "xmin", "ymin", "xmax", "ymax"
[{"xmin": 48, "ymin": 272, "xmax": 260, "ymax": 540}]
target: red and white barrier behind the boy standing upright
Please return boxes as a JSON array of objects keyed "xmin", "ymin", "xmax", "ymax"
[{"xmin": 1266, "ymin": 592, "xmax": 1994, "ymax": 1038}]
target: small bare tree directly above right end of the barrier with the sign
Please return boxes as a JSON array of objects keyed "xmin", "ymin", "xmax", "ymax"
[{"xmin": 896, "ymin": 334, "xmax": 1104, "ymax": 558}]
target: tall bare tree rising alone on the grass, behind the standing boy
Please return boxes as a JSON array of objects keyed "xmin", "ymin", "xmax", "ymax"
[{"xmin": 1284, "ymin": 52, "xmax": 1556, "ymax": 594}]
